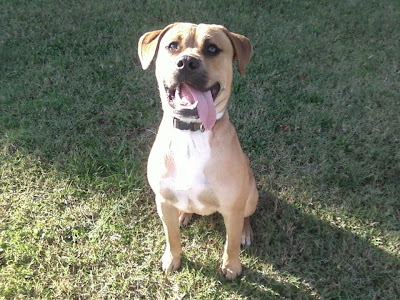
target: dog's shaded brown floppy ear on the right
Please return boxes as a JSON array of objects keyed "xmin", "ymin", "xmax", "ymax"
[{"xmin": 225, "ymin": 30, "xmax": 253, "ymax": 76}]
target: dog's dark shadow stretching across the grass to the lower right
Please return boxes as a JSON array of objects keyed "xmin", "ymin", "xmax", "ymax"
[{"xmin": 245, "ymin": 194, "xmax": 400, "ymax": 299}]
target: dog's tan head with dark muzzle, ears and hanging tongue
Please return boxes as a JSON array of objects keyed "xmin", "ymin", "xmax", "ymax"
[{"xmin": 138, "ymin": 23, "xmax": 252, "ymax": 129}]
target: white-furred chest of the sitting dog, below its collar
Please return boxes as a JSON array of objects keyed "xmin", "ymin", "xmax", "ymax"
[{"xmin": 161, "ymin": 130, "xmax": 216, "ymax": 215}]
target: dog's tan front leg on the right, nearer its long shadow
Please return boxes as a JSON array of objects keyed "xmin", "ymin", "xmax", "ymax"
[{"xmin": 222, "ymin": 212, "xmax": 244, "ymax": 280}]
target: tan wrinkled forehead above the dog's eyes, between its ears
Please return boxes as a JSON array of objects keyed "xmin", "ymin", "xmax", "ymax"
[{"xmin": 163, "ymin": 23, "xmax": 230, "ymax": 44}]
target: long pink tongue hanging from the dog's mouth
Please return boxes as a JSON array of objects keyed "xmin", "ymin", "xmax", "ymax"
[{"xmin": 181, "ymin": 83, "xmax": 217, "ymax": 130}]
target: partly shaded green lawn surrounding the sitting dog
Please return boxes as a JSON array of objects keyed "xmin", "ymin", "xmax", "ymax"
[{"xmin": 0, "ymin": 0, "xmax": 400, "ymax": 299}]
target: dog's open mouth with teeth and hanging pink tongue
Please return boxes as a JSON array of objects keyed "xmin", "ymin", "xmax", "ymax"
[{"xmin": 165, "ymin": 82, "xmax": 221, "ymax": 130}]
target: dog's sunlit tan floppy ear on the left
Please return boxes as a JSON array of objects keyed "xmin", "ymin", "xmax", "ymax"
[{"xmin": 138, "ymin": 23, "xmax": 175, "ymax": 70}]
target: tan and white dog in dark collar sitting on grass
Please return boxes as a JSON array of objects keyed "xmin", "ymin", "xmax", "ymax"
[{"xmin": 138, "ymin": 23, "xmax": 258, "ymax": 279}]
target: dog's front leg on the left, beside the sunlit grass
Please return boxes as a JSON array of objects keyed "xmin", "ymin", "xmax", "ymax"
[{"xmin": 156, "ymin": 196, "xmax": 182, "ymax": 272}]
